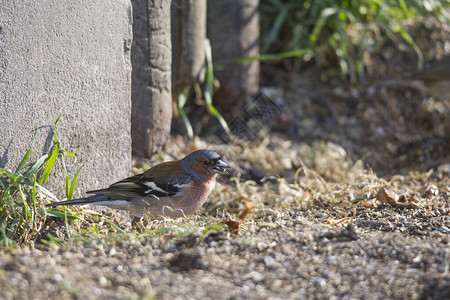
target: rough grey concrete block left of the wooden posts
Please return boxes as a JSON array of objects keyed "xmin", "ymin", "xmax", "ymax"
[{"xmin": 0, "ymin": 0, "xmax": 132, "ymax": 198}]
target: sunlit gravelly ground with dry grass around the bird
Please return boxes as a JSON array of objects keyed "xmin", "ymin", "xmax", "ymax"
[{"xmin": 0, "ymin": 17, "xmax": 450, "ymax": 299}]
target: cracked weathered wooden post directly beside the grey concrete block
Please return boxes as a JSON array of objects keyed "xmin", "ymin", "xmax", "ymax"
[{"xmin": 131, "ymin": 0, "xmax": 172, "ymax": 157}]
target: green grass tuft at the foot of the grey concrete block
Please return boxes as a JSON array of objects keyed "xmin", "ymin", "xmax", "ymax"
[{"xmin": 0, "ymin": 116, "xmax": 82, "ymax": 247}]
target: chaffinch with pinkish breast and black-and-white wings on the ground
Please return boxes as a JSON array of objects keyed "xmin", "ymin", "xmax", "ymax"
[{"xmin": 47, "ymin": 150, "xmax": 230, "ymax": 218}]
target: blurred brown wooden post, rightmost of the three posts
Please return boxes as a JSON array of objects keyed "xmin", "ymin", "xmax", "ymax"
[{"xmin": 208, "ymin": 0, "xmax": 259, "ymax": 118}]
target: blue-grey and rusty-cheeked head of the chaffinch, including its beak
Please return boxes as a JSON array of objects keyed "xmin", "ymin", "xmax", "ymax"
[{"xmin": 181, "ymin": 150, "xmax": 230, "ymax": 181}]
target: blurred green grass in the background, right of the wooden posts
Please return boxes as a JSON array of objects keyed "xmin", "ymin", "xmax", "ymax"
[{"xmin": 260, "ymin": 0, "xmax": 450, "ymax": 79}]
